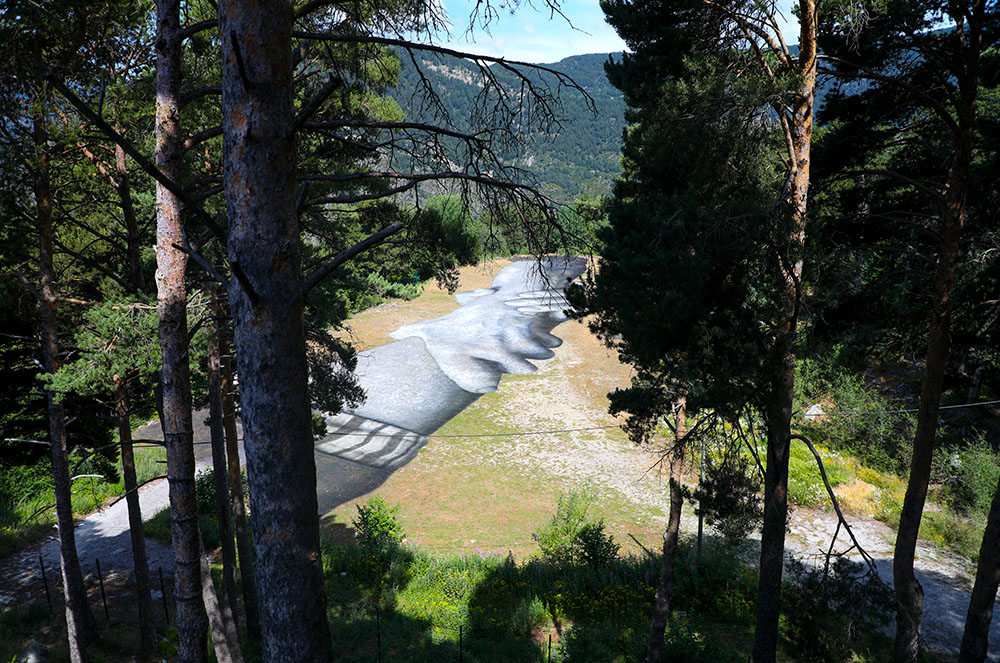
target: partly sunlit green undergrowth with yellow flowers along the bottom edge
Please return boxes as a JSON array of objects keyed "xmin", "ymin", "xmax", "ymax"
[{"xmin": 324, "ymin": 543, "xmax": 756, "ymax": 663}]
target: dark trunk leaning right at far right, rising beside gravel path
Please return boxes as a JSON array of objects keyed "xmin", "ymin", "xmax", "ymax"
[{"xmin": 892, "ymin": 127, "xmax": 975, "ymax": 663}]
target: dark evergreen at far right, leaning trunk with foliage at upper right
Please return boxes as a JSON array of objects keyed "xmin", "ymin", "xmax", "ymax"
[{"xmin": 824, "ymin": 5, "xmax": 1000, "ymax": 662}]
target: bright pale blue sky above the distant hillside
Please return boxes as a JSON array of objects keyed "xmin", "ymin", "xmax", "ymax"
[{"xmin": 441, "ymin": 0, "xmax": 798, "ymax": 62}]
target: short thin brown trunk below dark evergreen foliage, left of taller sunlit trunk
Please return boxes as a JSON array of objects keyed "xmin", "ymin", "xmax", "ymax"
[{"xmin": 646, "ymin": 398, "xmax": 686, "ymax": 663}]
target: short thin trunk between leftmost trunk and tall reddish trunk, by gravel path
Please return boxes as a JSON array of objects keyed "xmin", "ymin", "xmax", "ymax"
[{"xmin": 115, "ymin": 375, "xmax": 156, "ymax": 654}]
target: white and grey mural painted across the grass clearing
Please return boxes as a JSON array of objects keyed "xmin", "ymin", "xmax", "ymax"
[{"xmin": 317, "ymin": 258, "xmax": 586, "ymax": 469}]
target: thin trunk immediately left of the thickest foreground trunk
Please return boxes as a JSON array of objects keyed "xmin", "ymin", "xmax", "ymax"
[{"xmin": 219, "ymin": 297, "xmax": 260, "ymax": 641}]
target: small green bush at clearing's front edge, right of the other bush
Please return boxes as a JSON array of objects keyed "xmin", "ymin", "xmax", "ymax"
[{"xmin": 531, "ymin": 487, "xmax": 621, "ymax": 567}]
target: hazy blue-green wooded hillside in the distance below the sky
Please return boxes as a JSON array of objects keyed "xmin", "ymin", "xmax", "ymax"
[{"xmin": 392, "ymin": 53, "xmax": 625, "ymax": 202}]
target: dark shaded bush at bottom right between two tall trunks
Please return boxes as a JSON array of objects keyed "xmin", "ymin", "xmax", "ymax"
[{"xmin": 781, "ymin": 557, "xmax": 894, "ymax": 663}]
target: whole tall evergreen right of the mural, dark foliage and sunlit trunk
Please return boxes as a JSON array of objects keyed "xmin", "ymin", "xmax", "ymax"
[{"xmin": 577, "ymin": 0, "xmax": 817, "ymax": 662}]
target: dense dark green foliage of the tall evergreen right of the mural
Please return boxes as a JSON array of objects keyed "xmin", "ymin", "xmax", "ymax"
[{"xmin": 569, "ymin": 29, "xmax": 787, "ymax": 436}]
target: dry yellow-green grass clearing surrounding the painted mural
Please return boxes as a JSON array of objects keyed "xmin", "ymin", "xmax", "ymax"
[{"xmin": 323, "ymin": 261, "xmax": 667, "ymax": 555}]
